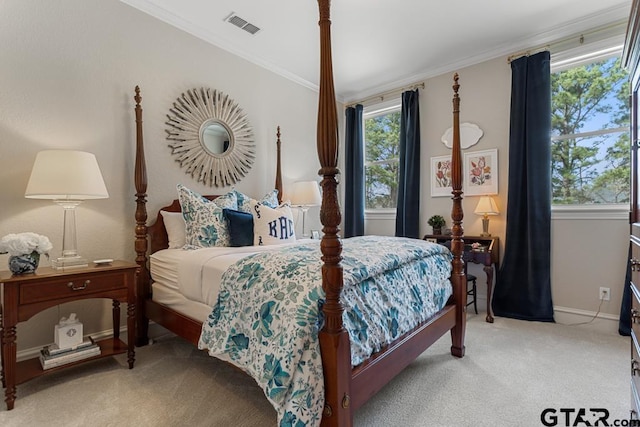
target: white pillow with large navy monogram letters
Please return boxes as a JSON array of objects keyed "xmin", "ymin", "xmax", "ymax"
[{"xmin": 251, "ymin": 203, "xmax": 296, "ymax": 246}]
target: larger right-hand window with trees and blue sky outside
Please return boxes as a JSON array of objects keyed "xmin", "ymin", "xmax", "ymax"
[{"xmin": 551, "ymin": 48, "xmax": 630, "ymax": 205}]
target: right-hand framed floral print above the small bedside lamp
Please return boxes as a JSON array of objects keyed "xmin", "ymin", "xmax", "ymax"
[{"xmin": 463, "ymin": 148, "xmax": 498, "ymax": 196}]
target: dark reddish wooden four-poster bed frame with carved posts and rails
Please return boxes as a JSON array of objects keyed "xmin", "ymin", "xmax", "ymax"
[{"xmin": 135, "ymin": 0, "xmax": 466, "ymax": 426}]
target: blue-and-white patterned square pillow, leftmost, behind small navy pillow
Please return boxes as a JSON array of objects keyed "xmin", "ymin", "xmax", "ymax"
[{"xmin": 177, "ymin": 184, "xmax": 238, "ymax": 249}]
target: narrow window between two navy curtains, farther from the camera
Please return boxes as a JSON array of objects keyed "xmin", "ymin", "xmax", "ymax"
[{"xmin": 363, "ymin": 101, "xmax": 401, "ymax": 210}]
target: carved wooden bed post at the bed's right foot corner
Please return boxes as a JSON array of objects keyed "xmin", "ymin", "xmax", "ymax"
[{"xmin": 451, "ymin": 73, "xmax": 467, "ymax": 357}]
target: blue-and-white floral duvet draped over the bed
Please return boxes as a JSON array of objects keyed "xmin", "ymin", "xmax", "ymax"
[{"xmin": 199, "ymin": 236, "xmax": 451, "ymax": 426}]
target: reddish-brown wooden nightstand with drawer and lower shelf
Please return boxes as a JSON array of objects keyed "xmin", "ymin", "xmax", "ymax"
[{"xmin": 0, "ymin": 261, "xmax": 138, "ymax": 410}]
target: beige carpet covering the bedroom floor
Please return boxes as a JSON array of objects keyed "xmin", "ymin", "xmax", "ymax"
[{"xmin": 0, "ymin": 313, "xmax": 630, "ymax": 427}]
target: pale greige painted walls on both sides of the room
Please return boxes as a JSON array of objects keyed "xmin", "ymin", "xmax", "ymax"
[{"xmin": 0, "ymin": 0, "xmax": 627, "ymax": 356}]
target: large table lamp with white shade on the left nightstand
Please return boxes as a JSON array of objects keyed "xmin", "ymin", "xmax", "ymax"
[{"xmin": 24, "ymin": 150, "xmax": 109, "ymax": 270}]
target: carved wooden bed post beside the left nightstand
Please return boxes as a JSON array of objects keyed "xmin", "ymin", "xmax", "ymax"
[{"xmin": 134, "ymin": 86, "xmax": 150, "ymax": 346}]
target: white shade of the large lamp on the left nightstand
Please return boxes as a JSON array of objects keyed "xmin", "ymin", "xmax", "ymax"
[{"xmin": 24, "ymin": 150, "xmax": 109, "ymax": 200}]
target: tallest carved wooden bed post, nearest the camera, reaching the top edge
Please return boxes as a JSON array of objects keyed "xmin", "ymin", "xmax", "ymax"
[{"xmin": 317, "ymin": 0, "xmax": 352, "ymax": 426}]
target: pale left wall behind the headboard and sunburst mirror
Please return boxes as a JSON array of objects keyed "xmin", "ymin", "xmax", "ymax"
[{"xmin": 0, "ymin": 0, "xmax": 319, "ymax": 349}]
